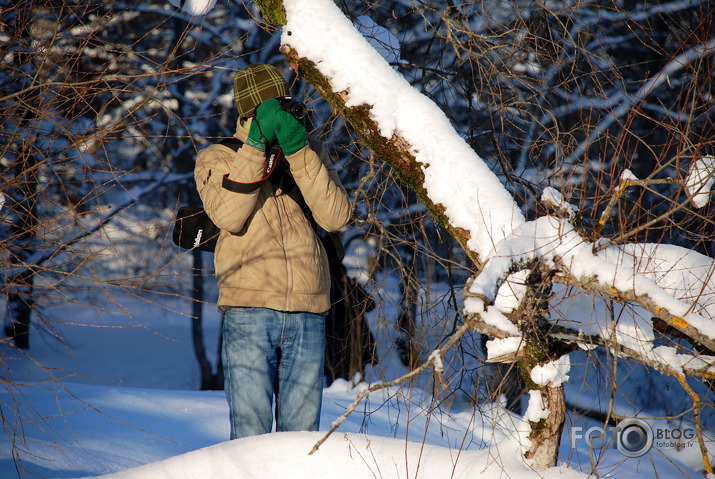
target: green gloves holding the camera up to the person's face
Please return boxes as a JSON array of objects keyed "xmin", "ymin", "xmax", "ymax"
[{"xmin": 253, "ymin": 98, "xmax": 308, "ymax": 156}]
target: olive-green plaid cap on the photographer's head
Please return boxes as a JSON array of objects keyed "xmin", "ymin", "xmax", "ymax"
[{"xmin": 233, "ymin": 63, "xmax": 289, "ymax": 118}]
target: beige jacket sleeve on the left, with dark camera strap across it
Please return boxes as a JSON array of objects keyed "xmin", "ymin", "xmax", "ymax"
[{"xmin": 194, "ymin": 145, "xmax": 265, "ymax": 233}]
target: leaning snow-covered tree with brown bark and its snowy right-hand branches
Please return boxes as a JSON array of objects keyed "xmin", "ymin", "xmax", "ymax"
[{"xmin": 250, "ymin": 0, "xmax": 715, "ymax": 470}]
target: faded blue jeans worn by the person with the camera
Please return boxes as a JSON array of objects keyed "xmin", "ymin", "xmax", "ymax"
[{"xmin": 221, "ymin": 308, "xmax": 325, "ymax": 439}]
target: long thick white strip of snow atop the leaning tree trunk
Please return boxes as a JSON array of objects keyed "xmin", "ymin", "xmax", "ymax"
[{"xmin": 282, "ymin": 0, "xmax": 524, "ymax": 255}]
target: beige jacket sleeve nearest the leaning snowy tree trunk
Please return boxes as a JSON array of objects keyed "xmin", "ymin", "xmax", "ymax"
[{"xmin": 286, "ymin": 142, "xmax": 352, "ymax": 231}]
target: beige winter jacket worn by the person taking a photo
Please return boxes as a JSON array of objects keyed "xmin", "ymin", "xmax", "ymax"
[{"xmin": 194, "ymin": 122, "xmax": 351, "ymax": 313}]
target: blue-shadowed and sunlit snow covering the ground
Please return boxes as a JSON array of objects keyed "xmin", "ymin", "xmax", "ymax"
[{"xmin": 0, "ymin": 284, "xmax": 704, "ymax": 479}]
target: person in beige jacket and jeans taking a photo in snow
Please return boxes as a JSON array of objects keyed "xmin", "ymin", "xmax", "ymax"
[{"xmin": 194, "ymin": 64, "xmax": 351, "ymax": 439}]
